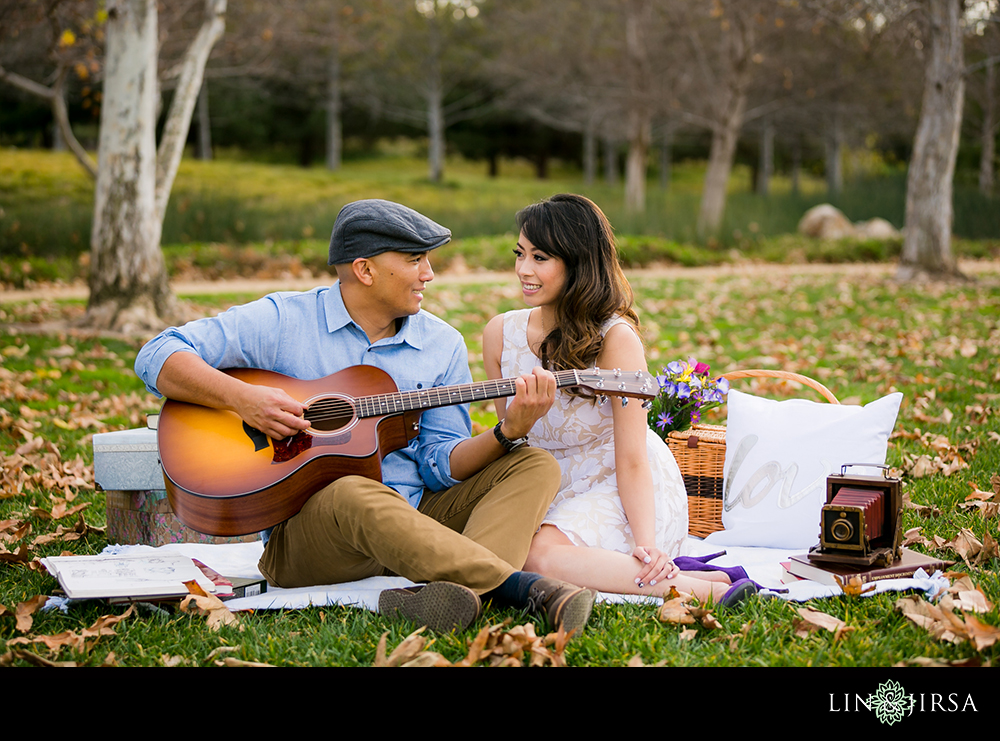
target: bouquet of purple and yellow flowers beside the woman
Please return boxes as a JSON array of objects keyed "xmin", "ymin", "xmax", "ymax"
[{"xmin": 649, "ymin": 358, "xmax": 729, "ymax": 439}]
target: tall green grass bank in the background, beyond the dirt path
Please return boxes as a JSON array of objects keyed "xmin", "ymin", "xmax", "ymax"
[{"xmin": 0, "ymin": 149, "xmax": 1000, "ymax": 264}]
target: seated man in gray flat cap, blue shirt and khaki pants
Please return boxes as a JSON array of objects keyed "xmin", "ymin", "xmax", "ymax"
[{"xmin": 135, "ymin": 200, "xmax": 593, "ymax": 631}]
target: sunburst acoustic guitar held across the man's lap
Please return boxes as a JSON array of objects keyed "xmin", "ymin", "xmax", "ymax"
[{"xmin": 158, "ymin": 365, "xmax": 659, "ymax": 535}]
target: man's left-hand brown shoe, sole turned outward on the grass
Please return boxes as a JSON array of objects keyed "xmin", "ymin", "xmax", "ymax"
[{"xmin": 378, "ymin": 581, "xmax": 482, "ymax": 633}]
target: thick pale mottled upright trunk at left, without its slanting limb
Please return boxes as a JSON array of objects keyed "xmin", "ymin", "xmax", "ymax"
[{"xmin": 86, "ymin": 0, "xmax": 175, "ymax": 331}]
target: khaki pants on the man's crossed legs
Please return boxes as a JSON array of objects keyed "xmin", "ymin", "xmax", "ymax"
[{"xmin": 259, "ymin": 448, "xmax": 560, "ymax": 594}]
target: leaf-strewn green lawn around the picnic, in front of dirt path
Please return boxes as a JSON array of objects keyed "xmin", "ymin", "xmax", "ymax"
[{"xmin": 0, "ymin": 270, "xmax": 1000, "ymax": 667}]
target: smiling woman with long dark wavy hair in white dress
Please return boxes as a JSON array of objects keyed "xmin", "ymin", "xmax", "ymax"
[{"xmin": 483, "ymin": 194, "xmax": 742, "ymax": 601}]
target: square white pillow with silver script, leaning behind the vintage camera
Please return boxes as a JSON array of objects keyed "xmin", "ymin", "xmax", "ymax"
[{"xmin": 705, "ymin": 390, "xmax": 903, "ymax": 549}]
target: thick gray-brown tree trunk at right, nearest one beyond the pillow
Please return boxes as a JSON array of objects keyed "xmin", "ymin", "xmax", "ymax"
[{"xmin": 897, "ymin": 0, "xmax": 965, "ymax": 280}]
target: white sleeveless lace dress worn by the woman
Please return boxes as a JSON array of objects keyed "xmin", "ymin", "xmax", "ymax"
[{"xmin": 500, "ymin": 309, "xmax": 688, "ymax": 556}]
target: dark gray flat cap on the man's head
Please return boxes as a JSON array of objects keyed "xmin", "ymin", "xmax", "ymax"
[{"xmin": 329, "ymin": 199, "xmax": 451, "ymax": 265}]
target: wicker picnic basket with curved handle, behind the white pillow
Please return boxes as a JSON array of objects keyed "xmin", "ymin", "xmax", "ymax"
[{"xmin": 667, "ymin": 370, "xmax": 840, "ymax": 538}]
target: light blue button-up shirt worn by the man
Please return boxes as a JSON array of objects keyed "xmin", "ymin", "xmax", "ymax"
[{"xmin": 135, "ymin": 282, "xmax": 472, "ymax": 507}]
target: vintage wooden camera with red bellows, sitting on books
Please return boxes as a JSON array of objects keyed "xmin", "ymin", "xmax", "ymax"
[{"xmin": 809, "ymin": 463, "xmax": 903, "ymax": 568}]
